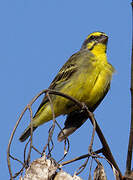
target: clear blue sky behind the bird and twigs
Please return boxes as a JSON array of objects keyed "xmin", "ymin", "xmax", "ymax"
[{"xmin": 0, "ymin": 0, "xmax": 131, "ymax": 179}]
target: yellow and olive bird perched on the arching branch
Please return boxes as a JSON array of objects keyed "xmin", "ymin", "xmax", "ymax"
[{"xmin": 19, "ymin": 32, "xmax": 114, "ymax": 142}]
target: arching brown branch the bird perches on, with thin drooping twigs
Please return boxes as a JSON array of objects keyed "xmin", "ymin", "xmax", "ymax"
[{"xmin": 7, "ymin": 89, "xmax": 122, "ymax": 180}]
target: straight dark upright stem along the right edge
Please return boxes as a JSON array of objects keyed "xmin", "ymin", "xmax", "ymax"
[{"xmin": 125, "ymin": 1, "xmax": 133, "ymax": 175}]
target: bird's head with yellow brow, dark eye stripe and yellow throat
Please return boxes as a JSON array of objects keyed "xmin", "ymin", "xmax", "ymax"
[{"xmin": 81, "ymin": 32, "xmax": 108, "ymax": 54}]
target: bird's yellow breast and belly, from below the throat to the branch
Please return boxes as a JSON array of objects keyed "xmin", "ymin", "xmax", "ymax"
[{"xmin": 55, "ymin": 57, "xmax": 113, "ymax": 114}]
